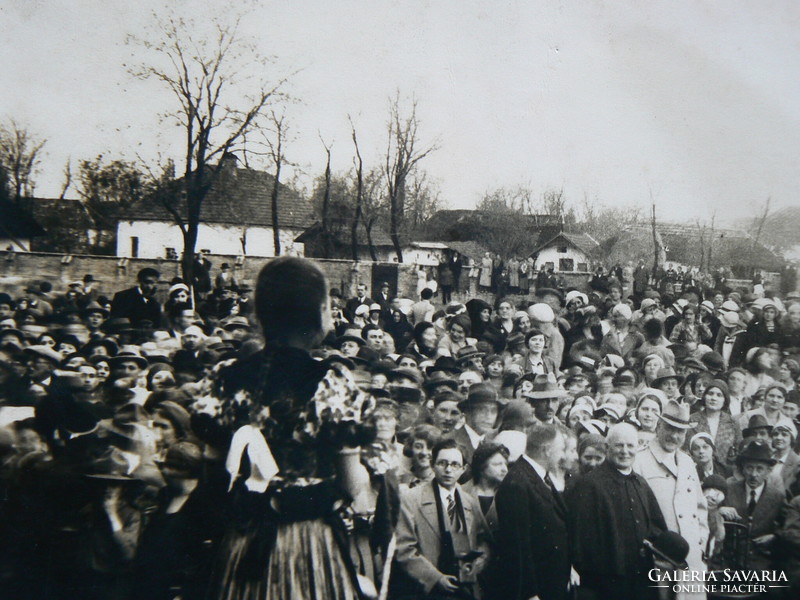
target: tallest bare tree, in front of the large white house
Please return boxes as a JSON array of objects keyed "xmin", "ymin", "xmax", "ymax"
[{"xmin": 130, "ymin": 17, "xmax": 286, "ymax": 282}]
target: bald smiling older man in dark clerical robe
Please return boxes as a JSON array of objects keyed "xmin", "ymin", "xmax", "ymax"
[{"xmin": 565, "ymin": 423, "xmax": 667, "ymax": 600}]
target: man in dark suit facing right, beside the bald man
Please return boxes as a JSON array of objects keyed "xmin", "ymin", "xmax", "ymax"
[{"xmin": 495, "ymin": 424, "xmax": 579, "ymax": 600}]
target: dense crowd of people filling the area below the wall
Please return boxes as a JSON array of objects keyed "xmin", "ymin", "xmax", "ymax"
[{"xmin": 0, "ymin": 257, "xmax": 800, "ymax": 600}]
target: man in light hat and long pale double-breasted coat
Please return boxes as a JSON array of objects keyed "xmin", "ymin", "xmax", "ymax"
[{"xmin": 634, "ymin": 400, "xmax": 708, "ymax": 598}]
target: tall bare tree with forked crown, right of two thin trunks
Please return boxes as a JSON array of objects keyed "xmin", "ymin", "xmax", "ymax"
[{"xmin": 384, "ymin": 93, "xmax": 438, "ymax": 262}]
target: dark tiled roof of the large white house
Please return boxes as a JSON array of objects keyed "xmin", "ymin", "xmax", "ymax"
[{"xmin": 120, "ymin": 167, "xmax": 314, "ymax": 229}]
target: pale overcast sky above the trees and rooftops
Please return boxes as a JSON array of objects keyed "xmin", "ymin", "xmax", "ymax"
[{"xmin": 0, "ymin": 0, "xmax": 800, "ymax": 223}]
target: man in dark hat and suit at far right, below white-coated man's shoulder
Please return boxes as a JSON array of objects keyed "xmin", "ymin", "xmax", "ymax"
[{"xmin": 719, "ymin": 440, "xmax": 786, "ymax": 570}]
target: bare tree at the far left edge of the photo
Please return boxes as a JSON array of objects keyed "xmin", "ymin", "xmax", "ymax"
[{"xmin": 0, "ymin": 119, "xmax": 47, "ymax": 202}]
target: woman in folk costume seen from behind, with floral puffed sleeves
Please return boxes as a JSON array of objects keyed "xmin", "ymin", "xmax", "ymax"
[{"xmin": 200, "ymin": 257, "xmax": 374, "ymax": 600}]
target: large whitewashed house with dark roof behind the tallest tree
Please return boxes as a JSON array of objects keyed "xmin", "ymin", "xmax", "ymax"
[{"xmin": 117, "ymin": 157, "xmax": 314, "ymax": 258}]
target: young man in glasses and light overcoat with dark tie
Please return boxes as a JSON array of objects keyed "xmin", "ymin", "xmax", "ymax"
[{"xmin": 393, "ymin": 439, "xmax": 491, "ymax": 600}]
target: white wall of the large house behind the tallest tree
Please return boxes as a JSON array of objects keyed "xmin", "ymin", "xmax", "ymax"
[{"xmin": 117, "ymin": 221, "xmax": 304, "ymax": 259}]
